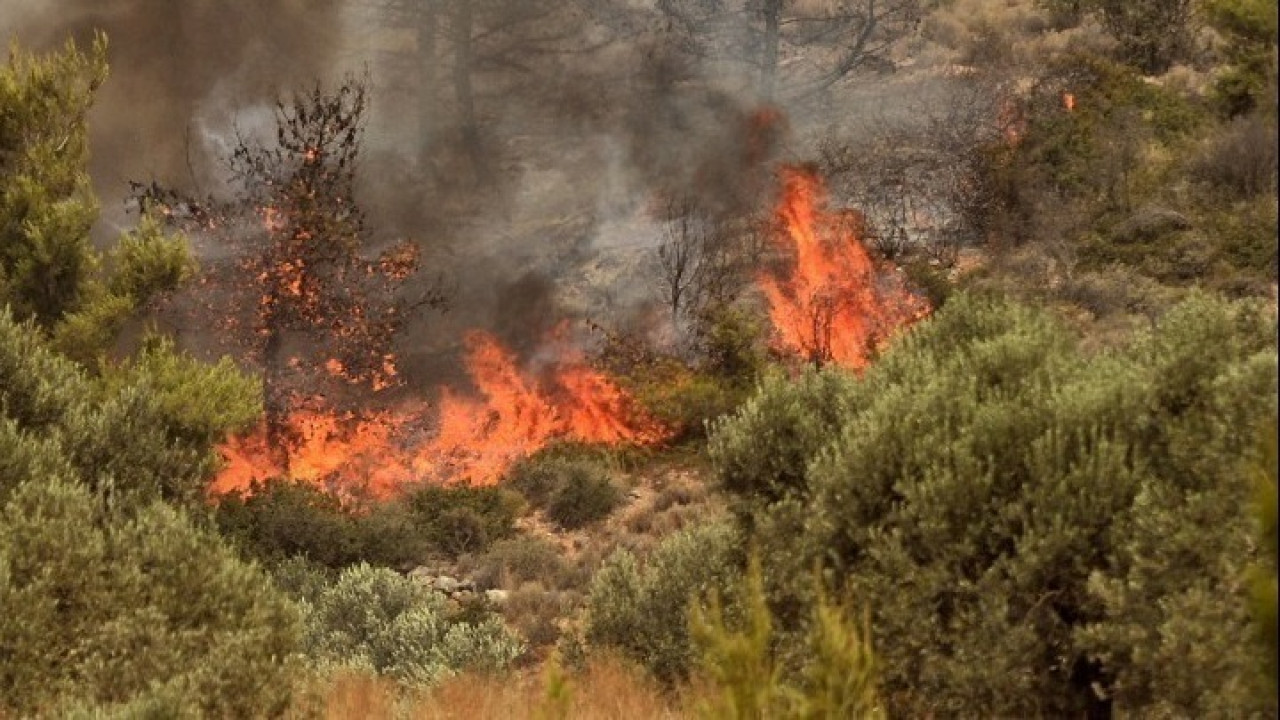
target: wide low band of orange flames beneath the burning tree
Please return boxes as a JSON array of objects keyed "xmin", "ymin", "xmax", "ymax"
[{"xmin": 211, "ymin": 325, "xmax": 667, "ymax": 497}]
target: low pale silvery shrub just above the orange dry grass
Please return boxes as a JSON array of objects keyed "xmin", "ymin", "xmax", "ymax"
[{"xmin": 305, "ymin": 564, "xmax": 525, "ymax": 684}]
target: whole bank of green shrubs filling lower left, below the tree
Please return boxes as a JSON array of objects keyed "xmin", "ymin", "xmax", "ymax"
[{"xmin": 0, "ymin": 302, "xmax": 286, "ymax": 716}]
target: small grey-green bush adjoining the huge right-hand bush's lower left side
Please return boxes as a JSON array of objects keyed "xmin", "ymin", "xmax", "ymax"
[{"xmin": 585, "ymin": 524, "xmax": 737, "ymax": 683}]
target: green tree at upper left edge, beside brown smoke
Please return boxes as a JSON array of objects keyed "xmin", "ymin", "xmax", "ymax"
[{"xmin": 0, "ymin": 36, "xmax": 191, "ymax": 361}]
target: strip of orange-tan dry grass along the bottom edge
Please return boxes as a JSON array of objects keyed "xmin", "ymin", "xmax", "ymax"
[{"xmin": 305, "ymin": 659, "xmax": 687, "ymax": 720}]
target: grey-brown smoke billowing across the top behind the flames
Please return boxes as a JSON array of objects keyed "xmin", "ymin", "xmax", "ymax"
[{"xmin": 0, "ymin": 0, "xmax": 926, "ymax": 384}]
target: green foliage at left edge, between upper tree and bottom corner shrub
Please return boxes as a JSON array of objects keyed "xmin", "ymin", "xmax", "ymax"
[{"xmin": 0, "ymin": 309, "xmax": 261, "ymax": 503}]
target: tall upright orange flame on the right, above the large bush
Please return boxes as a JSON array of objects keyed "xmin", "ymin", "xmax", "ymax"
[{"xmin": 759, "ymin": 168, "xmax": 928, "ymax": 368}]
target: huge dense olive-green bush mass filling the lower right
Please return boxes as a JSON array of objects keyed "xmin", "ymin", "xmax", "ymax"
[{"xmin": 712, "ymin": 289, "xmax": 1276, "ymax": 716}]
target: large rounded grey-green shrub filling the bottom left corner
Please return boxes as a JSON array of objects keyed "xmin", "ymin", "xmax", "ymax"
[{"xmin": 0, "ymin": 477, "xmax": 300, "ymax": 717}]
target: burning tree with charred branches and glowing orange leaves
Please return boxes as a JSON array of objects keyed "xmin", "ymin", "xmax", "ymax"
[{"xmin": 136, "ymin": 79, "xmax": 444, "ymax": 470}]
